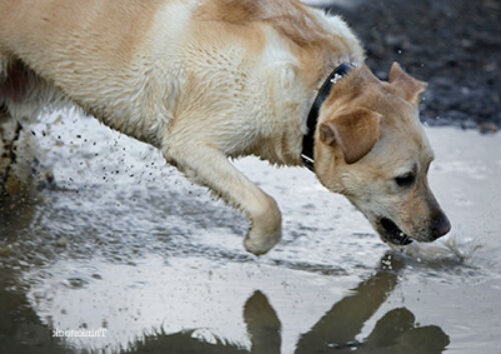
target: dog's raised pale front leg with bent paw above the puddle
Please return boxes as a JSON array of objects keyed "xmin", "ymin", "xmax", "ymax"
[{"xmin": 164, "ymin": 144, "xmax": 282, "ymax": 255}]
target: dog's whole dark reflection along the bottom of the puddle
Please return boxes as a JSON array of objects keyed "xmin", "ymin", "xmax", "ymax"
[{"xmin": 124, "ymin": 254, "xmax": 449, "ymax": 354}]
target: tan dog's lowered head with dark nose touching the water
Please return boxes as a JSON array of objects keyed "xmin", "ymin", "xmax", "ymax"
[{"xmin": 314, "ymin": 63, "xmax": 451, "ymax": 245}]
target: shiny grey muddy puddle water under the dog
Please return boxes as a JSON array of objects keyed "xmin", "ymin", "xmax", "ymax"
[{"xmin": 0, "ymin": 115, "xmax": 501, "ymax": 354}]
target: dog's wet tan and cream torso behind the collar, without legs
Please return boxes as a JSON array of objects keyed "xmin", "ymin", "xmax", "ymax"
[{"xmin": 0, "ymin": 0, "xmax": 363, "ymax": 146}]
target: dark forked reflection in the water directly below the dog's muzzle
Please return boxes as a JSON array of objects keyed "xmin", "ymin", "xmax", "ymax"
[{"xmin": 295, "ymin": 254, "xmax": 449, "ymax": 354}]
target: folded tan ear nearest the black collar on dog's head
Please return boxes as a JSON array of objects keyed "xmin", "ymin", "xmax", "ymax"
[{"xmin": 319, "ymin": 108, "xmax": 382, "ymax": 164}]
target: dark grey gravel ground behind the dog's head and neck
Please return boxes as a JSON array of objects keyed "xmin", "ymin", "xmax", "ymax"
[{"xmin": 324, "ymin": 0, "xmax": 501, "ymax": 132}]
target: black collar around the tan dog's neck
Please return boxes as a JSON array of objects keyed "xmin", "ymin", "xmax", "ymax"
[{"xmin": 301, "ymin": 63, "xmax": 353, "ymax": 171}]
